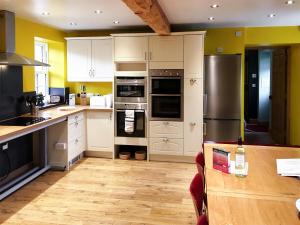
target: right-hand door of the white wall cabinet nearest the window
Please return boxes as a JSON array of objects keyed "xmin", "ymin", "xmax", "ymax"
[{"xmin": 91, "ymin": 39, "xmax": 113, "ymax": 81}]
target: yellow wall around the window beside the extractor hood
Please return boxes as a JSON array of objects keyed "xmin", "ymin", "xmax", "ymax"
[{"xmin": 16, "ymin": 18, "xmax": 65, "ymax": 91}]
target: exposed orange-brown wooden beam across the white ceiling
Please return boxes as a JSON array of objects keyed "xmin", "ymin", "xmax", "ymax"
[{"xmin": 122, "ymin": 0, "xmax": 170, "ymax": 35}]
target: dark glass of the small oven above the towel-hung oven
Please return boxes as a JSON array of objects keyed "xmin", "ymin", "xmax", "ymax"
[{"xmin": 117, "ymin": 84, "xmax": 145, "ymax": 98}]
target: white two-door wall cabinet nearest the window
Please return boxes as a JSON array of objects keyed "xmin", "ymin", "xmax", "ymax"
[{"xmin": 67, "ymin": 38, "xmax": 113, "ymax": 82}]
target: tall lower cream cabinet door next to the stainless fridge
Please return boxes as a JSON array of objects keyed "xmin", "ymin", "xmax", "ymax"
[{"xmin": 184, "ymin": 79, "xmax": 203, "ymax": 156}]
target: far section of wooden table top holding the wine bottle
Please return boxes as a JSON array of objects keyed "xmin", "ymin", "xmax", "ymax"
[{"xmin": 205, "ymin": 144, "xmax": 300, "ymax": 198}]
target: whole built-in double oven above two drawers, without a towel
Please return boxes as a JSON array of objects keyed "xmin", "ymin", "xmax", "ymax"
[{"xmin": 149, "ymin": 69, "xmax": 184, "ymax": 121}]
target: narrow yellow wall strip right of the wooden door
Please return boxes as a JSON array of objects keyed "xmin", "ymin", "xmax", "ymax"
[{"xmin": 290, "ymin": 44, "xmax": 300, "ymax": 145}]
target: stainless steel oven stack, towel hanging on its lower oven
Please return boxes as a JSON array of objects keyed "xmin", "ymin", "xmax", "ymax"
[{"xmin": 114, "ymin": 77, "xmax": 148, "ymax": 138}]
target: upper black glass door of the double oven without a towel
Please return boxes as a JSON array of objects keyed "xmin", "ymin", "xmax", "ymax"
[{"xmin": 151, "ymin": 77, "xmax": 181, "ymax": 94}]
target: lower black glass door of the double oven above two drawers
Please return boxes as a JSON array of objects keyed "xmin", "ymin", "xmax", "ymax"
[{"xmin": 151, "ymin": 96, "xmax": 181, "ymax": 119}]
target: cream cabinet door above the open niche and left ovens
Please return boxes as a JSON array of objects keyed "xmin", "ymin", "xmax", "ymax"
[{"xmin": 114, "ymin": 37, "xmax": 148, "ymax": 62}]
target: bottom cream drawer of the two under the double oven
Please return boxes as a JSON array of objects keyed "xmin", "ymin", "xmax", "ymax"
[{"xmin": 149, "ymin": 138, "xmax": 183, "ymax": 155}]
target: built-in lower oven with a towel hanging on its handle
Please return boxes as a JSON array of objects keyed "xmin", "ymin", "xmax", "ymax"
[{"xmin": 115, "ymin": 103, "xmax": 147, "ymax": 138}]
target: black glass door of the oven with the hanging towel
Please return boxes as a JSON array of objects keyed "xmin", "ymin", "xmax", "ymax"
[{"xmin": 117, "ymin": 110, "xmax": 146, "ymax": 137}]
